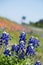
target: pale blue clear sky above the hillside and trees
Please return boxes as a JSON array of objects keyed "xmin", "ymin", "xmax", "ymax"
[{"xmin": 0, "ymin": 0, "xmax": 43, "ymax": 23}]
